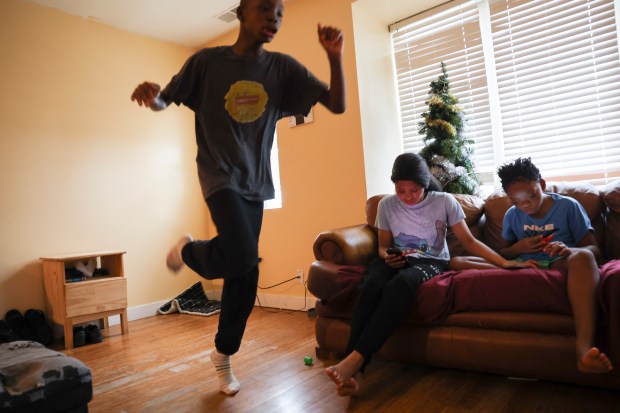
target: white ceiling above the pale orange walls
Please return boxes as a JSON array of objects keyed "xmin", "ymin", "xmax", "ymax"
[{"xmin": 26, "ymin": 0, "xmax": 443, "ymax": 48}]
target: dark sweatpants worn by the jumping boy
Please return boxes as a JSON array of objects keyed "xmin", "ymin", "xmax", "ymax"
[{"xmin": 182, "ymin": 189, "xmax": 263, "ymax": 355}]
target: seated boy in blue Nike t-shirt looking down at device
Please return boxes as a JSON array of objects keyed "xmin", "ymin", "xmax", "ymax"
[{"xmin": 450, "ymin": 158, "xmax": 613, "ymax": 373}]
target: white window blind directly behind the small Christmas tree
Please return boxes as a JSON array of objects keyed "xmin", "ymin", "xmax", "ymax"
[{"xmin": 391, "ymin": 1, "xmax": 494, "ymax": 172}]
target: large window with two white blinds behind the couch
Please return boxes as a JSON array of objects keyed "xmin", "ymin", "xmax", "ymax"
[{"xmin": 390, "ymin": 0, "xmax": 620, "ymax": 184}]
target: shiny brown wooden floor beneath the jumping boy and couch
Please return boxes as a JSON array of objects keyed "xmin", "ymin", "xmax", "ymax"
[{"xmin": 65, "ymin": 308, "xmax": 620, "ymax": 413}]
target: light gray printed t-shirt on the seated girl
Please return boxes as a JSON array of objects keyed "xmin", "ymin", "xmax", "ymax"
[{"xmin": 377, "ymin": 191, "xmax": 465, "ymax": 260}]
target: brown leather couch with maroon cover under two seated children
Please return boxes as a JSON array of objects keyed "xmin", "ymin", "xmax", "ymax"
[{"xmin": 308, "ymin": 181, "xmax": 620, "ymax": 389}]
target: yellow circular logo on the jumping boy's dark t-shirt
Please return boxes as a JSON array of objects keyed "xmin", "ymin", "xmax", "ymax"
[{"xmin": 225, "ymin": 80, "xmax": 269, "ymax": 123}]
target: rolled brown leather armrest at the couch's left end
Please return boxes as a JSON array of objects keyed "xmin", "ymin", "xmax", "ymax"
[{"xmin": 312, "ymin": 224, "xmax": 377, "ymax": 265}]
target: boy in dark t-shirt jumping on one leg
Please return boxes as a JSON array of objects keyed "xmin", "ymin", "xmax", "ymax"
[{"xmin": 131, "ymin": 0, "xmax": 345, "ymax": 395}]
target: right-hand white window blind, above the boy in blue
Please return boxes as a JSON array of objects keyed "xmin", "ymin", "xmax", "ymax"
[{"xmin": 490, "ymin": 0, "xmax": 620, "ymax": 183}]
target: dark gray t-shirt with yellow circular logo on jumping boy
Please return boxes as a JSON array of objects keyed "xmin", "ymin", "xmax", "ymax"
[{"xmin": 162, "ymin": 46, "xmax": 327, "ymax": 201}]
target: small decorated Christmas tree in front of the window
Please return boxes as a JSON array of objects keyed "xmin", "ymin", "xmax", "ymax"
[{"xmin": 418, "ymin": 62, "xmax": 481, "ymax": 194}]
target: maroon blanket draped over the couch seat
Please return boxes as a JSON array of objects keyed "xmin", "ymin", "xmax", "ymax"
[{"xmin": 334, "ymin": 260, "xmax": 620, "ymax": 364}]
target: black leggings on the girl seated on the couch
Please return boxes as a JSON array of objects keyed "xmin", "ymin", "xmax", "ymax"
[{"xmin": 347, "ymin": 258, "xmax": 448, "ymax": 371}]
